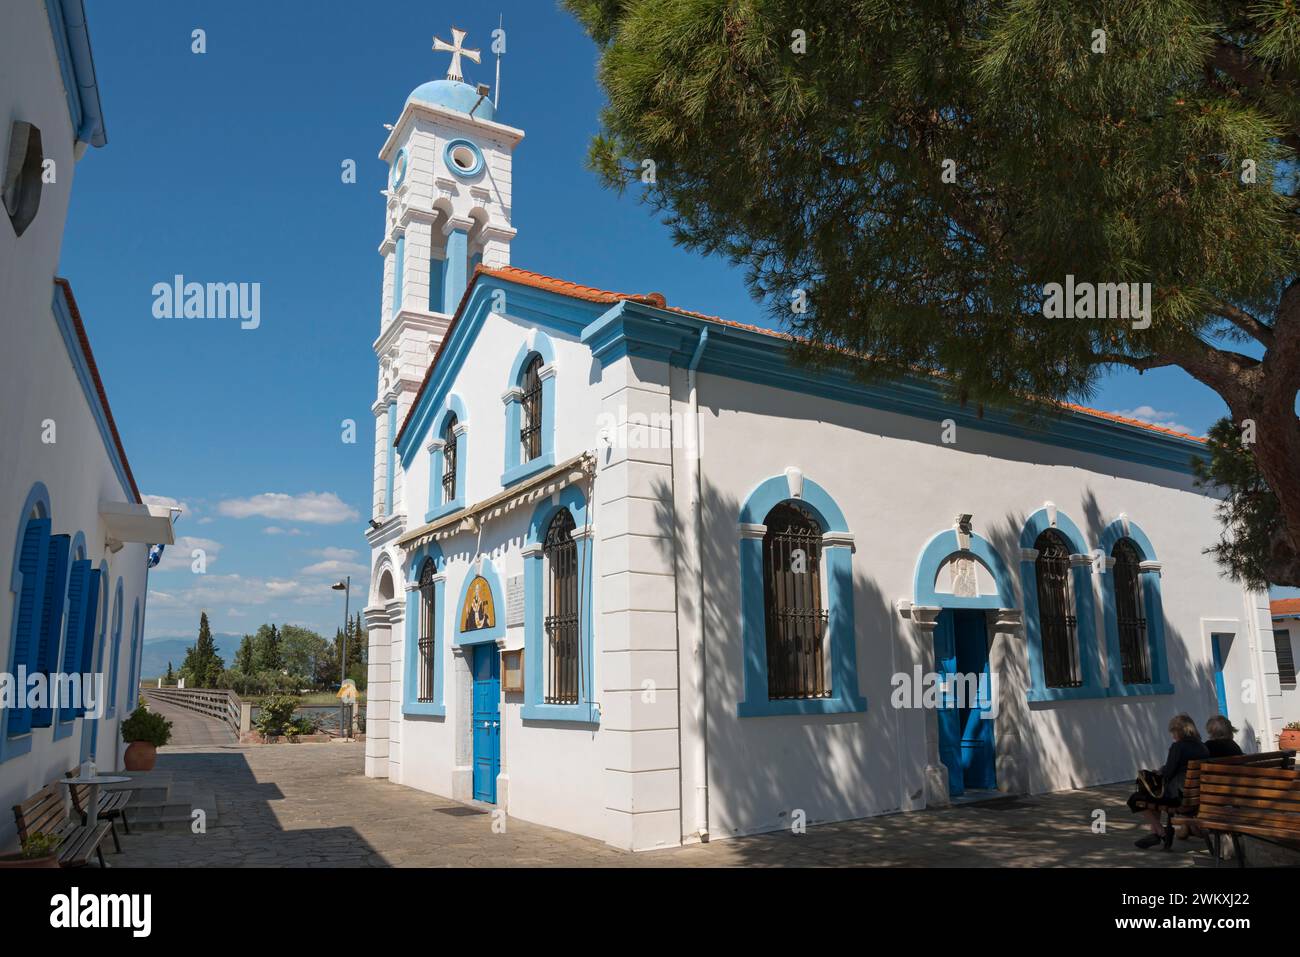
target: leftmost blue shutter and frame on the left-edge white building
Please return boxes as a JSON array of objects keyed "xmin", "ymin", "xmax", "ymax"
[{"xmin": 0, "ymin": 482, "xmax": 51, "ymax": 762}]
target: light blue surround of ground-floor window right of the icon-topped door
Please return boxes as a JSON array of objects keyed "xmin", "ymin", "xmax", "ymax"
[{"xmin": 521, "ymin": 485, "xmax": 601, "ymax": 724}]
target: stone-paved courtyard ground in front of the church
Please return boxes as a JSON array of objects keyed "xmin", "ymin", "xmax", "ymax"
[{"xmin": 109, "ymin": 744, "xmax": 1213, "ymax": 867}]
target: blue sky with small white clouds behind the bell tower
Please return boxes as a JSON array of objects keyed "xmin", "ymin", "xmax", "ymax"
[{"xmin": 60, "ymin": 0, "xmax": 1279, "ymax": 637}]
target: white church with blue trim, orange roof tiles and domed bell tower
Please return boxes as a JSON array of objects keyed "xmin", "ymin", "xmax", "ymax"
[{"xmin": 365, "ymin": 31, "xmax": 1282, "ymax": 850}]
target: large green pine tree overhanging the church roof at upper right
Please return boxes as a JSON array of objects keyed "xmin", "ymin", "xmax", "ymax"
[{"xmin": 574, "ymin": 0, "xmax": 1300, "ymax": 585}]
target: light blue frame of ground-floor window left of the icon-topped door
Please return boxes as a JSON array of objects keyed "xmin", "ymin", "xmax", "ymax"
[{"xmin": 402, "ymin": 542, "xmax": 447, "ymax": 718}]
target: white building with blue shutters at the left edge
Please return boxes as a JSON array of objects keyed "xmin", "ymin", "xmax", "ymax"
[{"xmin": 0, "ymin": 0, "xmax": 173, "ymax": 852}]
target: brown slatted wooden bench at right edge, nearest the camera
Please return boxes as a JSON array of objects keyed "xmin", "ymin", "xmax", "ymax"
[{"xmin": 1170, "ymin": 750, "xmax": 1300, "ymax": 867}]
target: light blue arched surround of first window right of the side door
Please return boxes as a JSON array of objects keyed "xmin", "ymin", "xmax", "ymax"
[{"xmin": 1021, "ymin": 507, "xmax": 1106, "ymax": 701}]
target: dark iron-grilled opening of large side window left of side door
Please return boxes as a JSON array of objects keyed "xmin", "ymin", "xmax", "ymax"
[{"xmin": 763, "ymin": 502, "xmax": 831, "ymax": 701}]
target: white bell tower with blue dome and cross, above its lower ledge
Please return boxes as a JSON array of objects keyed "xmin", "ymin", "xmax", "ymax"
[{"xmin": 372, "ymin": 27, "xmax": 524, "ymax": 525}]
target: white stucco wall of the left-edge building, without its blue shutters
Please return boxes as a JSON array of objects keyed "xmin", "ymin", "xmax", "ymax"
[{"xmin": 0, "ymin": 0, "xmax": 147, "ymax": 850}]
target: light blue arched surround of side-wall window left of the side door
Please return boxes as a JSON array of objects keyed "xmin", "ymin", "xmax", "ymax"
[{"xmin": 736, "ymin": 468, "xmax": 867, "ymax": 718}]
